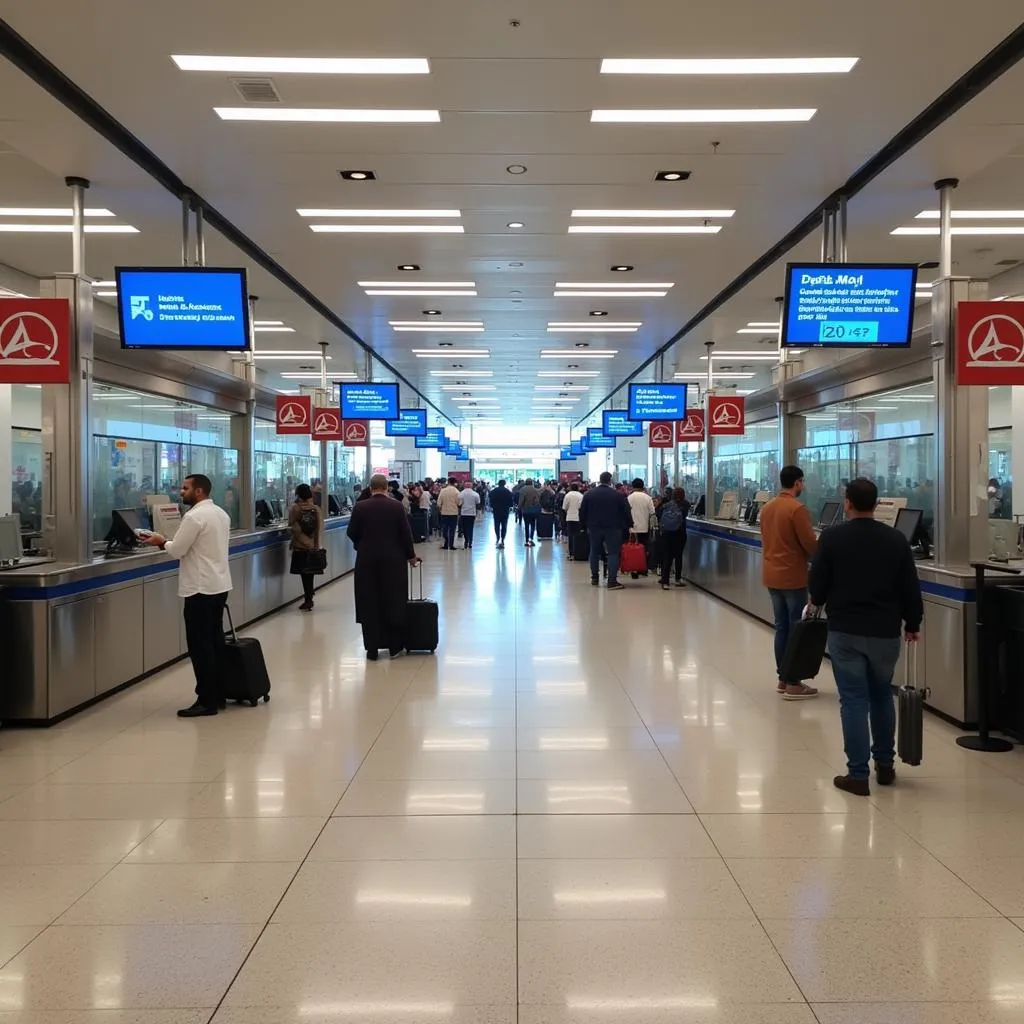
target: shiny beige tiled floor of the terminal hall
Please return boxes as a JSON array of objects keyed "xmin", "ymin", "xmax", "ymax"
[{"xmin": 0, "ymin": 530, "xmax": 1024, "ymax": 1024}]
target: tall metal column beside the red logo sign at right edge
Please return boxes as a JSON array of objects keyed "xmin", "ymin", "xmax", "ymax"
[{"xmin": 932, "ymin": 178, "xmax": 988, "ymax": 565}]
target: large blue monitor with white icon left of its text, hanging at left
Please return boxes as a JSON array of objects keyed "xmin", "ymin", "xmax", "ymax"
[{"xmin": 114, "ymin": 266, "xmax": 249, "ymax": 352}]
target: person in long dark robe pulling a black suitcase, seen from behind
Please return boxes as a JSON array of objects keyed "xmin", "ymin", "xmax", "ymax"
[{"xmin": 348, "ymin": 473, "xmax": 420, "ymax": 662}]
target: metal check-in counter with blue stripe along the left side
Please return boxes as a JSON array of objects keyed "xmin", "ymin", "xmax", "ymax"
[{"xmin": 0, "ymin": 516, "xmax": 355, "ymax": 723}]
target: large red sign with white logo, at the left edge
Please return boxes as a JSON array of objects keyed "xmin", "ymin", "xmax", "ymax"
[{"xmin": 0, "ymin": 298, "xmax": 71, "ymax": 384}]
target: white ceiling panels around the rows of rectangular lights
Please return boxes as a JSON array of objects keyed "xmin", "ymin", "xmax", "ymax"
[{"xmin": 0, "ymin": 0, "xmax": 1024, "ymax": 422}]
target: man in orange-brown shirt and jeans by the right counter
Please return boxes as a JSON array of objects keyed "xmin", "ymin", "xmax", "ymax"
[{"xmin": 761, "ymin": 466, "xmax": 818, "ymax": 700}]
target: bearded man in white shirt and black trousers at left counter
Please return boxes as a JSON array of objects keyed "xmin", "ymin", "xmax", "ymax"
[{"xmin": 142, "ymin": 473, "xmax": 231, "ymax": 718}]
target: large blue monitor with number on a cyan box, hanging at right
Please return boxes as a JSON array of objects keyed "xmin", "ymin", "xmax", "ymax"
[{"xmin": 782, "ymin": 263, "xmax": 918, "ymax": 348}]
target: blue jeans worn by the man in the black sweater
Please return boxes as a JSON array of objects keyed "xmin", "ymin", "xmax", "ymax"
[{"xmin": 828, "ymin": 633, "xmax": 900, "ymax": 778}]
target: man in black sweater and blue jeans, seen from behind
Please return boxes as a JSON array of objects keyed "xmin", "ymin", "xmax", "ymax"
[{"xmin": 809, "ymin": 477, "xmax": 925, "ymax": 797}]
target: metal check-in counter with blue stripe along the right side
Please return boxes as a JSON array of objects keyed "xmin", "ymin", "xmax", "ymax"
[{"xmin": 685, "ymin": 519, "xmax": 978, "ymax": 728}]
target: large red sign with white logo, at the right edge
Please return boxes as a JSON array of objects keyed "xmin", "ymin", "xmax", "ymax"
[{"xmin": 956, "ymin": 302, "xmax": 1024, "ymax": 386}]
